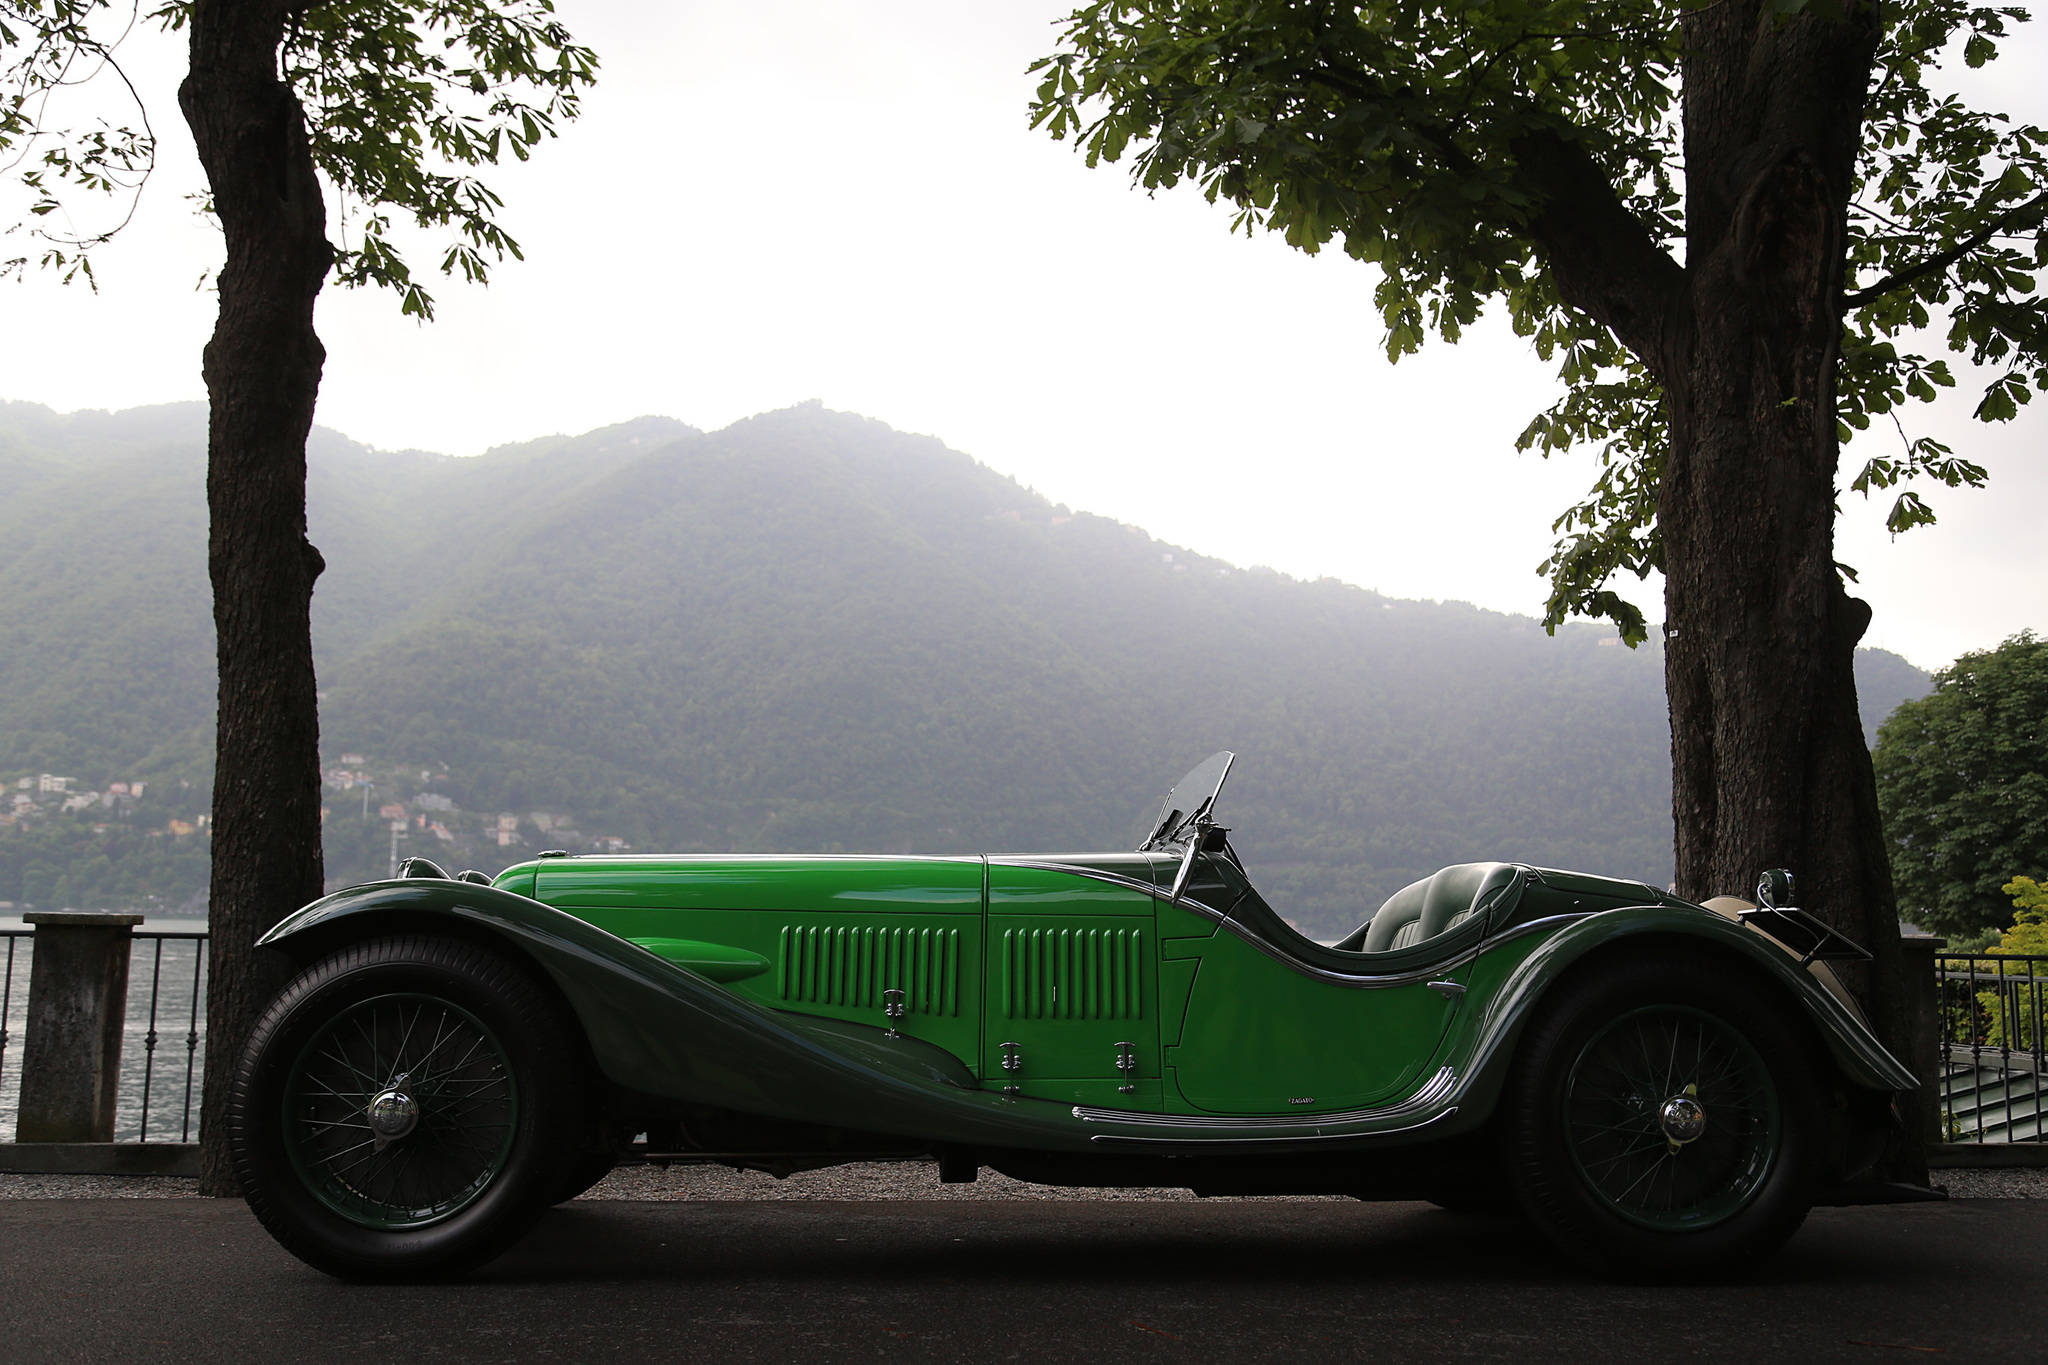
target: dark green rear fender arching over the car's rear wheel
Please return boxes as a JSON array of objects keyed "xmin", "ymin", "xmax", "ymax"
[{"xmin": 1460, "ymin": 905, "xmax": 1919, "ymax": 1117}]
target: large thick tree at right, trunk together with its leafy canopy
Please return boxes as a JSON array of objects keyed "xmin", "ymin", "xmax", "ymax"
[{"xmin": 1034, "ymin": 0, "xmax": 2048, "ymax": 1175}]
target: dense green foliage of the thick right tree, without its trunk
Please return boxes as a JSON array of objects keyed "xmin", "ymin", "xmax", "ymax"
[{"xmin": 1032, "ymin": 0, "xmax": 2048, "ymax": 643}]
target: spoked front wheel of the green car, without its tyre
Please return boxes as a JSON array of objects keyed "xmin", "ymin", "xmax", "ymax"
[{"xmin": 281, "ymin": 993, "xmax": 520, "ymax": 1230}]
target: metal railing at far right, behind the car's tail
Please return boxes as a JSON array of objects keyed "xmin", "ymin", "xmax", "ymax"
[{"xmin": 1933, "ymin": 954, "xmax": 2048, "ymax": 1142}]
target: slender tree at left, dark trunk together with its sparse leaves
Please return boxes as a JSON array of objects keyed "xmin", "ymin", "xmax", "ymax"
[{"xmin": 0, "ymin": 0, "xmax": 596, "ymax": 1193}]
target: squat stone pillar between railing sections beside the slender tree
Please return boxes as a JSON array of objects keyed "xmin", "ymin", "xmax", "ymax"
[{"xmin": 14, "ymin": 911, "xmax": 141, "ymax": 1142}]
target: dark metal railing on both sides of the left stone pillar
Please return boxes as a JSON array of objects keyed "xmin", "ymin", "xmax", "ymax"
[{"xmin": 0, "ymin": 929, "xmax": 207, "ymax": 1142}]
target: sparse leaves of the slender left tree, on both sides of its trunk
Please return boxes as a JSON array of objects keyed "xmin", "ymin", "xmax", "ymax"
[{"xmin": 0, "ymin": 0, "xmax": 598, "ymax": 319}]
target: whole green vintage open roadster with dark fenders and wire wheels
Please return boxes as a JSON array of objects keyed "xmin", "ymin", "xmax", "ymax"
[{"xmin": 229, "ymin": 753, "xmax": 1915, "ymax": 1279}]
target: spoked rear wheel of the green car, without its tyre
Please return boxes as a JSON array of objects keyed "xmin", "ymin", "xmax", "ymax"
[{"xmin": 1561, "ymin": 1005, "xmax": 1784, "ymax": 1232}]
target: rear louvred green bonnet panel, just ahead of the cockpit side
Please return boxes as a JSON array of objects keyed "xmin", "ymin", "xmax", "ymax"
[{"xmin": 981, "ymin": 862, "xmax": 1163, "ymax": 1111}]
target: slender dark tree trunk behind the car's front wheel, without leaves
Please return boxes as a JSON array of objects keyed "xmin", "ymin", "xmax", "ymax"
[{"xmin": 178, "ymin": 0, "xmax": 334, "ymax": 1195}]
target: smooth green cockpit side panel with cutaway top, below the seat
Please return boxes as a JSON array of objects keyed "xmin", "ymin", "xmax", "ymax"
[{"xmin": 1159, "ymin": 905, "xmax": 1481, "ymax": 1115}]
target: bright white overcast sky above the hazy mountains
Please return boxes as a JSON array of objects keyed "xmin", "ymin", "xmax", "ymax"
[{"xmin": 0, "ymin": 0, "xmax": 2048, "ymax": 667}]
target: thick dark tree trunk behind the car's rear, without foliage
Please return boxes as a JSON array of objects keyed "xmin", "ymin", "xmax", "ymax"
[{"xmin": 1653, "ymin": 4, "xmax": 1931, "ymax": 1183}]
